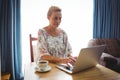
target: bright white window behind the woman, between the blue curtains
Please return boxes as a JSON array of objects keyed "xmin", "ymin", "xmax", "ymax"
[{"xmin": 21, "ymin": 0, "xmax": 93, "ymax": 73}]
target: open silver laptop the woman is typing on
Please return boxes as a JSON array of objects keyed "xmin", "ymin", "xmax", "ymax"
[{"xmin": 56, "ymin": 45, "xmax": 105, "ymax": 74}]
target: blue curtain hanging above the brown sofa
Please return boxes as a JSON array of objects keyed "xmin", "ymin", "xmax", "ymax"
[{"xmin": 93, "ymin": 0, "xmax": 120, "ymax": 38}]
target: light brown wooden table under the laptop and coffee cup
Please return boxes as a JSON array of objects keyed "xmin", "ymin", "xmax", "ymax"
[{"xmin": 24, "ymin": 63, "xmax": 120, "ymax": 80}]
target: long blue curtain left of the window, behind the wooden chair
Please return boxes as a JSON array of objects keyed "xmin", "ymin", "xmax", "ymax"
[{"xmin": 0, "ymin": 0, "xmax": 23, "ymax": 80}]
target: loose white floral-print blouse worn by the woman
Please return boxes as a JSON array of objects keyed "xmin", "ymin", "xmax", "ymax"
[{"xmin": 37, "ymin": 29, "xmax": 72, "ymax": 58}]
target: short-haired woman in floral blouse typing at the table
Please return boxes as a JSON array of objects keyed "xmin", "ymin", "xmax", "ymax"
[{"xmin": 38, "ymin": 6, "xmax": 76, "ymax": 64}]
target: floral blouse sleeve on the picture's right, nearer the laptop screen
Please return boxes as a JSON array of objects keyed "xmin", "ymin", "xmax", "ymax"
[{"xmin": 63, "ymin": 31, "xmax": 72, "ymax": 55}]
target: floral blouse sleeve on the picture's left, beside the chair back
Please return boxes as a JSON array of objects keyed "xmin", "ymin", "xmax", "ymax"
[{"xmin": 37, "ymin": 29, "xmax": 49, "ymax": 56}]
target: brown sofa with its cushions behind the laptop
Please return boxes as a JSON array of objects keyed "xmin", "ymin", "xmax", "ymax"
[{"xmin": 88, "ymin": 39, "xmax": 120, "ymax": 73}]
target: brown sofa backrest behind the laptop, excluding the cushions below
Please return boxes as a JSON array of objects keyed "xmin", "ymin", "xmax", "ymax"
[{"xmin": 88, "ymin": 39, "xmax": 120, "ymax": 57}]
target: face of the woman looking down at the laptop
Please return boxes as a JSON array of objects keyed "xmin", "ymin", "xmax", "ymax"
[{"xmin": 48, "ymin": 12, "xmax": 62, "ymax": 28}]
